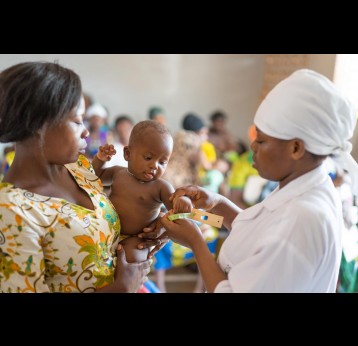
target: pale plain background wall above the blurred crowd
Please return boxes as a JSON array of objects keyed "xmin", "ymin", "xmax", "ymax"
[{"xmin": 0, "ymin": 54, "xmax": 264, "ymax": 140}]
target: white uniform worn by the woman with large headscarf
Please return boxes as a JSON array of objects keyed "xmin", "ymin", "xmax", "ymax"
[{"xmin": 215, "ymin": 166, "xmax": 343, "ymax": 292}]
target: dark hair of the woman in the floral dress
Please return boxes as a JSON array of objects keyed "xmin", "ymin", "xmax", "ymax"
[{"xmin": 0, "ymin": 62, "xmax": 82, "ymax": 143}]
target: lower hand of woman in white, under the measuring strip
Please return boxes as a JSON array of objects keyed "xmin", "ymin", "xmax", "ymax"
[{"xmin": 161, "ymin": 212, "xmax": 205, "ymax": 249}]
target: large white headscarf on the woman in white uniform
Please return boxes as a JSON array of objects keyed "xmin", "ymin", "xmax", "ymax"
[{"xmin": 254, "ymin": 69, "xmax": 358, "ymax": 194}]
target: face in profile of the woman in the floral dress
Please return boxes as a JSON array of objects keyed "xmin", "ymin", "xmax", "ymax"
[{"xmin": 43, "ymin": 97, "xmax": 89, "ymax": 165}]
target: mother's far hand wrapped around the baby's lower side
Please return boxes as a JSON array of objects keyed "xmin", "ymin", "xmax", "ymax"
[{"xmin": 138, "ymin": 213, "xmax": 169, "ymax": 258}]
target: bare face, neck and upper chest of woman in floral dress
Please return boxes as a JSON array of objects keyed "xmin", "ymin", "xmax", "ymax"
[{"xmin": 4, "ymin": 100, "xmax": 94, "ymax": 204}]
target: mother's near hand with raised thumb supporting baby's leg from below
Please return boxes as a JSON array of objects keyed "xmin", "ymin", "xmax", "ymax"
[{"xmin": 96, "ymin": 245, "xmax": 152, "ymax": 293}]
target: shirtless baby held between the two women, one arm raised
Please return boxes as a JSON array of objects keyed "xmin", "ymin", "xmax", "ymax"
[{"xmin": 92, "ymin": 120, "xmax": 192, "ymax": 262}]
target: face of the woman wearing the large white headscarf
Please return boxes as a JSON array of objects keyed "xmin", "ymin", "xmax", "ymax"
[{"xmin": 251, "ymin": 128, "xmax": 295, "ymax": 185}]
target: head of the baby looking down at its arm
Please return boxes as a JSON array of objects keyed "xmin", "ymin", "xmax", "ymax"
[{"xmin": 124, "ymin": 120, "xmax": 173, "ymax": 182}]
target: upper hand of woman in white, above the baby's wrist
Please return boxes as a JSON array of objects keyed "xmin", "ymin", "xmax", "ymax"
[{"xmin": 169, "ymin": 185, "xmax": 220, "ymax": 210}]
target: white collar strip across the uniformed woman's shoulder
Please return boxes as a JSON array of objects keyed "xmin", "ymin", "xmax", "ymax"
[{"xmin": 238, "ymin": 165, "xmax": 330, "ymax": 220}]
